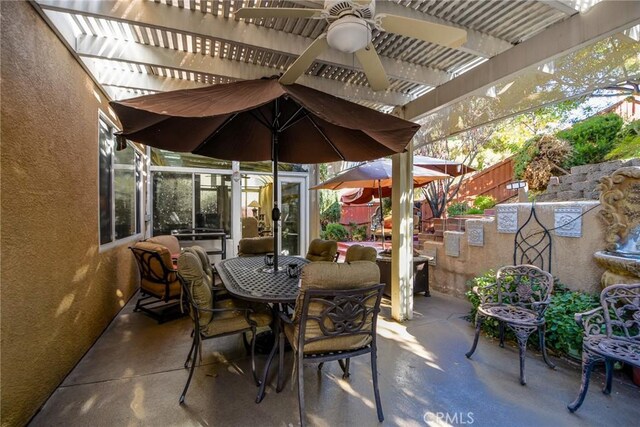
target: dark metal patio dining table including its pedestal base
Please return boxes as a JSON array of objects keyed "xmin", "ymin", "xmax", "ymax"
[{"xmin": 216, "ymin": 256, "xmax": 309, "ymax": 403}]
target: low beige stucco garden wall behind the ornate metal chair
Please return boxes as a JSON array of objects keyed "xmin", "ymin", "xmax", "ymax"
[{"xmin": 424, "ymin": 201, "xmax": 604, "ymax": 297}]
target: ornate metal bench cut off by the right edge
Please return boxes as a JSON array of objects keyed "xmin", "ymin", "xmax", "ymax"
[{"xmin": 567, "ymin": 283, "xmax": 640, "ymax": 412}]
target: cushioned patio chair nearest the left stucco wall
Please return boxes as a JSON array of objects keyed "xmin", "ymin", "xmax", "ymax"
[{"xmin": 129, "ymin": 241, "xmax": 180, "ymax": 323}]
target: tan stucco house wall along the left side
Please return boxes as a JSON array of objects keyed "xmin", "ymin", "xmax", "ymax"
[{"xmin": 0, "ymin": 1, "xmax": 137, "ymax": 426}]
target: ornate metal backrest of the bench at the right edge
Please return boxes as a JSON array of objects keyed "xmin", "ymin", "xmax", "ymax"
[{"xmin": 600, "ymin": 283, "xmax": 640, "ymax": 341}]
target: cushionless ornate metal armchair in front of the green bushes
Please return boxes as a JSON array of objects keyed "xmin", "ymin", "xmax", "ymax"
[{"xmin": 466, "ymin": 264, "xmax": 555, "ymax": 385}]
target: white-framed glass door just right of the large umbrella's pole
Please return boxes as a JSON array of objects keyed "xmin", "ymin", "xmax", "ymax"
[{"xmin": 279, "ymin": 177, "xmax": 308, "ymax": 255}]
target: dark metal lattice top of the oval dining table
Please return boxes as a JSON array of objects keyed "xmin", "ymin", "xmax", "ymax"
[{"xmin": 216, "ymin": 256, "xmax": 309, "ymax": 303}]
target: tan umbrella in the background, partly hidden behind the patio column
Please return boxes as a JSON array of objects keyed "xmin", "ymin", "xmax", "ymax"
[{"xmin": 311, "ymin": 159, "xmax": 450, "ymax": 247}]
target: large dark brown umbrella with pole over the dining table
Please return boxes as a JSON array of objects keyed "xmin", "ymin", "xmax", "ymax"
[{"xmin": 111, "ymin": 78, "xmax": 419, "ymax": 271}]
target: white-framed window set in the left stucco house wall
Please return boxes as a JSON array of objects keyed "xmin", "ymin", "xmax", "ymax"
[{"xmin": 99, "ymin": 116, "xmax": 142, "ymax": 245}]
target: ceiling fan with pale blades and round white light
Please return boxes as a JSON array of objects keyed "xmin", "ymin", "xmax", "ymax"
[{"xmin": 235, "ymin": 0, "xmax": 467, "ymax": 91}]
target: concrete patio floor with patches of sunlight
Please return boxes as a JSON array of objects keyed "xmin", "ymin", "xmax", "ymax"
[{"xmin": 30, "ymin": 292, "xmax": 640, "ymax": 426}]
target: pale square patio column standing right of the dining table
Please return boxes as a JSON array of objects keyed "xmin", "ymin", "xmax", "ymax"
[{"xmin": 391, "ymin": 141, "xmax": 413, "ymax": 322}]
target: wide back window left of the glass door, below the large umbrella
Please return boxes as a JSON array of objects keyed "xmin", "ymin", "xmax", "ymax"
[{"xmin": 153, "ymin": 171, "xmax": 231, "ymax": 236}]
